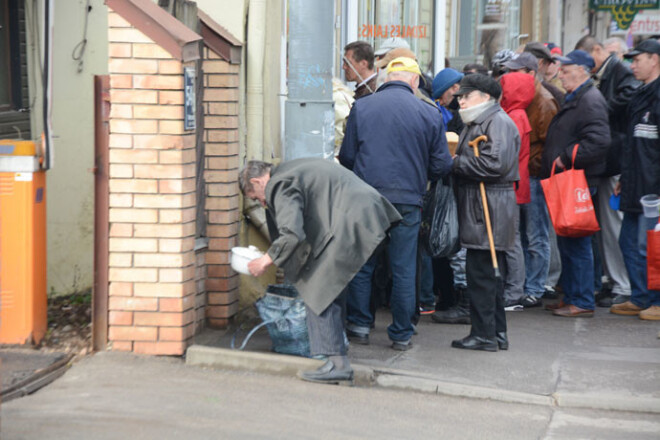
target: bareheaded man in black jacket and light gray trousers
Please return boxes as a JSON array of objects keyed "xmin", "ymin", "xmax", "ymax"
[{"xmin": 575, "ymin": 35, "xmax": 639, "ymax": 307}]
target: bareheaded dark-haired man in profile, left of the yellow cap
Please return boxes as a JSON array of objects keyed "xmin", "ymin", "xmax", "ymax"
[{"xmin": 342, "ymin": 41, "xmax": 378, "ymax": 99}]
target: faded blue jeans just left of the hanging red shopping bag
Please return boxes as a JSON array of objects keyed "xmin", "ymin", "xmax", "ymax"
[{"xmin": 520, "ymin": 177, "xmax": 551, "ymax": 298}]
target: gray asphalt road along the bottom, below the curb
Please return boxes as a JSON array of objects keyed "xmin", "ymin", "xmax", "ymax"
[{"xmin": 0, "ymin": 353, "xmax": 660, "ymax": 440}]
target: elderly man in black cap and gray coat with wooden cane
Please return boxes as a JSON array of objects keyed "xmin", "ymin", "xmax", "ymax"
[{"xmin": 451, "ymin": 73, "xmax": 520, "ymax": 351}]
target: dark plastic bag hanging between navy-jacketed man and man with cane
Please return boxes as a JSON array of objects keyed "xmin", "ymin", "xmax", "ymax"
[{"xmin": 420, "ymin": 178, "xmax": 461, "ymax": 258}]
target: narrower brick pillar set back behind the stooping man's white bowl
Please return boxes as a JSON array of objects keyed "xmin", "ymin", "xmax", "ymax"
[{"xmin": 202, "ymin": 47, "xmax": 239, "ymax": 327}]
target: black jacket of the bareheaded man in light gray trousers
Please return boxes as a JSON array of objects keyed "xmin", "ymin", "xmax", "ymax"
[{"xmin": 598, "ymin": 55, "xmax": 639, "ymax": 176}]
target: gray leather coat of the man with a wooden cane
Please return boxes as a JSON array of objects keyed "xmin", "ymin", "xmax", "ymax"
[{"xmin": 453, "ymin": 104, "xmax": 520, "ymax": 251}]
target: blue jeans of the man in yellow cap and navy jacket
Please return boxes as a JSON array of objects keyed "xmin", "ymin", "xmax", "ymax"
[{"xmin": 346, "ymin": 203, "xmax": 422, "ymax": 342}]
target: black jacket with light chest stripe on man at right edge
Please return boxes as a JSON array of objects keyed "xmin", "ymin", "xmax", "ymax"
[{"xmin": 620, "ymin": 79, "xmax": 660, "ymax": 213}]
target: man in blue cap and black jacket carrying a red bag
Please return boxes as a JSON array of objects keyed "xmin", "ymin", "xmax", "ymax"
[{"xmin": 541, "ymin": 50, "xmax": 611, "ymax": 317}]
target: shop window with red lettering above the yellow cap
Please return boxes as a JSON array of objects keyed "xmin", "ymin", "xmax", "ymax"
[{"xmin": 358, "ymin": 0, "xmax": 434, "ymax": 70}]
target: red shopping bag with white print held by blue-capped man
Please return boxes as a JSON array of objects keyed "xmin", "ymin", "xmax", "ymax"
[{"xmin": 541, "ymin": 144, "xmax": 600, "ymax": 237}]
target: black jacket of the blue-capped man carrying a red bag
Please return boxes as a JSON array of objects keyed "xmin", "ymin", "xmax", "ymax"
[{"xmin": 540, "ymin": 80, "xmax": 611, "ymax": 186}]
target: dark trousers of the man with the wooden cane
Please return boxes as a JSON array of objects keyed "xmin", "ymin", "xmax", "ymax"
[{"xmin": 465, "ymin": 249, "xmax": 506, "ymax": 338}]
